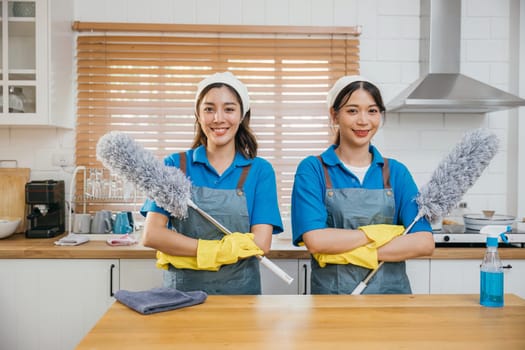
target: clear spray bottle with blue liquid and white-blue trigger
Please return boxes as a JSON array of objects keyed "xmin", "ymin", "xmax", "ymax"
[{"xmin": 479, "ymin": 225, "xmax": 512, "ymax": 307}]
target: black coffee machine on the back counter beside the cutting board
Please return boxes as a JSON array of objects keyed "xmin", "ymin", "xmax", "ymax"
[{"xmin": 26, "ymin": 180, "xmax": 66, "ymax": 238}]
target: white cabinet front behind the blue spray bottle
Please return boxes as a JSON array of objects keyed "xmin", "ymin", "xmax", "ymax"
[{"xmin": 430, "ymin": 259, "xmax": 525, "ymax": 298}]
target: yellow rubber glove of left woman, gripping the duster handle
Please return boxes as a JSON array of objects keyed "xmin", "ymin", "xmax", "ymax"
[{"xmin": 197, "ymin": 232, "xmax": 264, "ymax": 271}]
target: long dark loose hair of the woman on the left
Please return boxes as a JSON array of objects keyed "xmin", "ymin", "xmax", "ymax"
[{"xmin": 191, "ymin": 83, "xmax": 257, "ymax": 159}]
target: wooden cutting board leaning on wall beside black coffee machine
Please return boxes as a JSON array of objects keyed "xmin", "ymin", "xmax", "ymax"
[{"xmin": 0, "ymin": 168, "xmax": 31, "ymax": 232}]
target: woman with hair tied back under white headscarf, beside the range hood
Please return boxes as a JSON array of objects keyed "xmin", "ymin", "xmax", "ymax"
[{"xmin": 292, "ymin": 76, "xmax": 434, "ymax": 294}]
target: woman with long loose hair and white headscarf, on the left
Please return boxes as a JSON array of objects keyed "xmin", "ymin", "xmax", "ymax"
[{"xmin": 141, "ymin": 72, "xmax": 282, "ymax": 294}]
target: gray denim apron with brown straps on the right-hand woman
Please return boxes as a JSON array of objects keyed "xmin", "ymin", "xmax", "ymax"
[{"xmin": 311, "ymin": 157, "xmax": 412, "ymax": 294}]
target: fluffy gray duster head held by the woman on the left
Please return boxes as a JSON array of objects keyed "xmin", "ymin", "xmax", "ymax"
[{"xmin": 97, "ymin": 132, "xmax": 191, "ymax": 218}]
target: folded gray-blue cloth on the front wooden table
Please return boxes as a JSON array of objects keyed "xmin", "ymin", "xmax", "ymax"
[{"xmin": 115, "ymin": 288, "xmax": 208, "ymax": 315}]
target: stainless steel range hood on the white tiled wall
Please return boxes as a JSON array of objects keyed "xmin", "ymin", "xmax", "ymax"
[{"xmin": 386, "ymin": 0, "xmax": 525, "ymax": 113}]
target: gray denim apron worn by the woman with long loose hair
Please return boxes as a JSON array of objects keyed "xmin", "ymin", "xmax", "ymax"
[{"xmin": 164, "ymin": 153, "xmax": 261, "ymax": 294}]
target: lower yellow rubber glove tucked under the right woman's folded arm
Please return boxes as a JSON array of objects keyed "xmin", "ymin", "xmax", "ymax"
[{"xmin": 313, "ymin": 245, "xmax": 379, "ymax": 269}]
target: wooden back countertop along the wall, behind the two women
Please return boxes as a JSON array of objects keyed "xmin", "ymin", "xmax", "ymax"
[{"xmin": 0, "ymin": 233, "xmax": 525, "ymax": 259}]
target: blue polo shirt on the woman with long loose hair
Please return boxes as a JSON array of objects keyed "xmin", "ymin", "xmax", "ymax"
[{"xmin": 141, "ymin": 146, "xmax": 283, "ymax": 234}]
